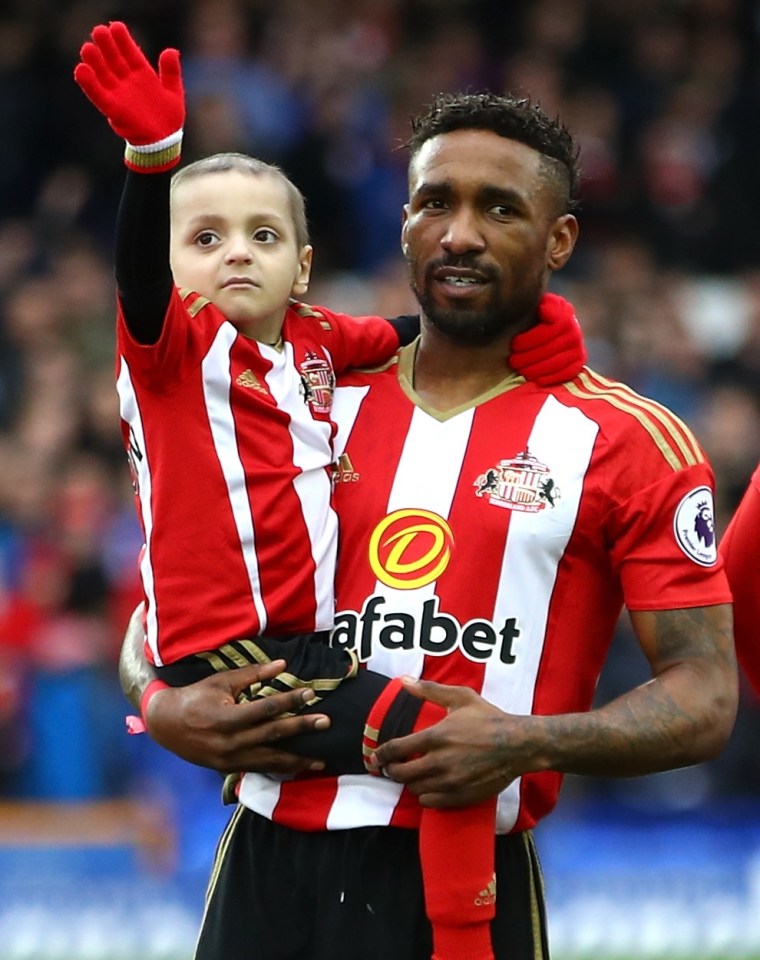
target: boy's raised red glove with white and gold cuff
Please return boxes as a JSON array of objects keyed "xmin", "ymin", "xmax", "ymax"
[{"xmin": 74, "ymin": 20, "xmax": 185, "ymax": 173}]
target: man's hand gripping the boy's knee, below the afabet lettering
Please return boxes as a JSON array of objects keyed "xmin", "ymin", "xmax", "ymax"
[{"xmin": 371, "ymin": 680, "xmax": 532, "ymax": 807}]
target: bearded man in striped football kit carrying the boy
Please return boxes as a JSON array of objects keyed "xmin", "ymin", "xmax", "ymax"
[{"xmin": 98, "ymin": 22, "xmax": 737, "ymax": 960}]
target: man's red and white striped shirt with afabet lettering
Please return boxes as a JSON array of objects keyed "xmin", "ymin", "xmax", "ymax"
[{"xmin": 240, "ymin": 347, "xmax": 730, "ymax": 833}]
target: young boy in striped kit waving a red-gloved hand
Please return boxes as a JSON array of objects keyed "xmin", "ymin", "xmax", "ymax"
[{"xmin": 75, "ymin": 22, "xmax": 583, "ymax": 960}]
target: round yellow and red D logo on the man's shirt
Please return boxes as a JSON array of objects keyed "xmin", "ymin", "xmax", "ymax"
[{"xmin": 369, "ymin": 510, "xmax": 454, "ymax": 590}]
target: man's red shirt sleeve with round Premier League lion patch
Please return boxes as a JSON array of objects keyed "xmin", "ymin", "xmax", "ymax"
[{"xmin": 607, "ymin": 463, "xmax": 731, "ymax": 610}]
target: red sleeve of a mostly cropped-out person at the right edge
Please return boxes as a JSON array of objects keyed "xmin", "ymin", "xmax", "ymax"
[{"xmin": 720, "ymin": 467, "xmax": 760, "ymax": 695}]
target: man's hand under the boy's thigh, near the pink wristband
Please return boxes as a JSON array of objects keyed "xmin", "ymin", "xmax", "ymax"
[{"xmin": 146, "ymin": 661, "xmax": 330, "ymax": 774}]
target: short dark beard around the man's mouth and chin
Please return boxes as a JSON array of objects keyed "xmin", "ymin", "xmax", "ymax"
[{"xmin": 409, "ymin": 257, "xmax": 541, "ymax": 347}]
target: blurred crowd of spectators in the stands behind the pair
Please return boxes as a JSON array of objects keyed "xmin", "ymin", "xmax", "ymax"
[{"xmin": 0, "ymin": 0, "xmax": 760, "ymax": 805}]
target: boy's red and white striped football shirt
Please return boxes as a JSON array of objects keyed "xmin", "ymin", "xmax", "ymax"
[{"xmin": 117, "ymin": 290, "xmax": 398, "ymax": 665}]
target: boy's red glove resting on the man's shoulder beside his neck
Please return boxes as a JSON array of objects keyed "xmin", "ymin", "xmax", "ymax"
[{"xmin": 509, "ymin": 293, "xmax": 588, "ymax": 387}]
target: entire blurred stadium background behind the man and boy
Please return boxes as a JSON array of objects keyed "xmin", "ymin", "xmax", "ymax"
[{"xmin": 0, "ymin": 0, "xmax": 760, "ymax": 960}]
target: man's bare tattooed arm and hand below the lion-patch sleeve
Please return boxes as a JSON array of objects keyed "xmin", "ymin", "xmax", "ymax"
[{"xmin": 376, "ymin": 604, "xmax": 738, "ymax": 807}]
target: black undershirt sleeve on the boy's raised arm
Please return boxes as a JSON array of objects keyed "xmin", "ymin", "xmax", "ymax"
[{"xmin": 114, "ymin": 170, "xmax": 174, "ymax": 344}]
